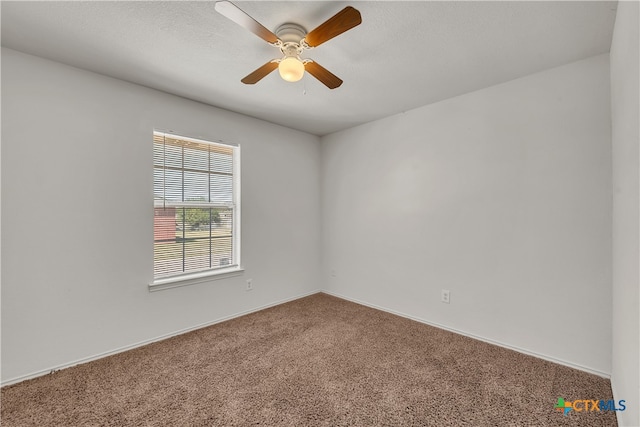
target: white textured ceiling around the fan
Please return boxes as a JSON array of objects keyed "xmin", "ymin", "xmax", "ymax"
[{"xmin": 1, "ymin": 1, "xmax": 617, "ymax": 135}]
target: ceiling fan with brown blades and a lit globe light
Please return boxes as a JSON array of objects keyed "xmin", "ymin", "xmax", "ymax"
[{"xmin": 215, "ymin": 1, "xmax": 362, "ymax": 89}]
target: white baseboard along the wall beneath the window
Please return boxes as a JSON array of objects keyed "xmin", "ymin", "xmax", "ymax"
[{"xmin": 0, "ymin": 290, "xmax": 321, "ymax": 387}]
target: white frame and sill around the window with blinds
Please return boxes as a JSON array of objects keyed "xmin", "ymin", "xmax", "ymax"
[{"xmin": 149, "ymin": 130, "xmax": 244, "ymax": 291}]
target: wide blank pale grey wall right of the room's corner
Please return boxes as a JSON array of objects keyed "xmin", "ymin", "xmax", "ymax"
[{"xmin": 321, "ymin": 55, "xmax": 611, "ymax": 375}]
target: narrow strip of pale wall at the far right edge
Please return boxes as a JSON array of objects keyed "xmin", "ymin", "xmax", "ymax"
[{"xmin": 611, "ymin": 1, "xmax": 640, "ymax": 426}]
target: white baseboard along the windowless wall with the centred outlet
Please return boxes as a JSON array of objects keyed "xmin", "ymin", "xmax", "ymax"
[{"xmin": 322, "ymin": 289, "xmax": 611, "ymax": 380}]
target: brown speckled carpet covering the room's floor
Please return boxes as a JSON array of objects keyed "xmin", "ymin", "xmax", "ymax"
[{"xmin": 2, "ymin": 294, "xmax": 616, "ymax": 427}]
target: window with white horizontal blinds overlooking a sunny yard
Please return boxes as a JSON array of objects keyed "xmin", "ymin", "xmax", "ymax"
[{"xmin": 153, "ymin": 132, "xmax": 240, "ymax": 284}]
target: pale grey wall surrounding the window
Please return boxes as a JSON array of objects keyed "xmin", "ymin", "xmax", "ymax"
[{"xmin": 1, "ymin": 49, "xmax": 320, "ymax": 383}]
